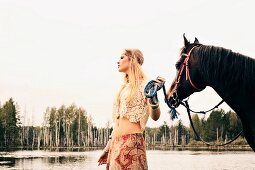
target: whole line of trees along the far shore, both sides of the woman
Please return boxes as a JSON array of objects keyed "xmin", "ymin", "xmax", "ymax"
[{"xmin": 0, "ymin": 98, "xmax": 247, "ymax": 149}]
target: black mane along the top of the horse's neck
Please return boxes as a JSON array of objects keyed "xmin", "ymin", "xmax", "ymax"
[{"xmin": 194, "ymin": 45, "xmax": 255, "ymax": 90}]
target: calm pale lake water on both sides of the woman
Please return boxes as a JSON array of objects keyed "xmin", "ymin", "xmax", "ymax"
[{"xmin": 0, "ymin": 150, "xmax": 255, "ymax": 170}]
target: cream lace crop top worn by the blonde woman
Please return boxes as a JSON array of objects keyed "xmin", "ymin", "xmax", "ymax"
[{"xmin": 113, "ymin": 83, "xmax": 149, "ymax": 130}]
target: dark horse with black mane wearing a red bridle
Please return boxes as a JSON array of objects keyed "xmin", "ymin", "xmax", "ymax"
[{"xmin": 167, "ymin": 34, "xmax": 255, "ymax": 152}]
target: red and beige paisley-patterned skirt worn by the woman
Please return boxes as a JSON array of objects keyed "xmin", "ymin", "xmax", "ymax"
[{"xmin": 106, "ymin": 133, "xmax": 148, "ymax": 170}]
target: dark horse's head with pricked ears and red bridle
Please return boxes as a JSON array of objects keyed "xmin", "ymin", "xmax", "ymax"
[{"xmin": 167, "ymin": 34, "xmax": 206, "ymax": 107}]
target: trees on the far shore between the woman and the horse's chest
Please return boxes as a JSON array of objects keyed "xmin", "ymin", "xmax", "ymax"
[{"xmin": 145, "ymin": 109, "xmax": 244, "ymax": 146}]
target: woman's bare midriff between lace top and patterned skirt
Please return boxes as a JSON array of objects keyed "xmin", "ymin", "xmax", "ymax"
[{"xmin": 115, "ymin": 117, "xmax": 142, "ymax": 136}]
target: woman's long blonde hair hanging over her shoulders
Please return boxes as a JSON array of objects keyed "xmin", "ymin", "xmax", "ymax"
[{"xmin": 116, "ymin": 48, "xmax": 145, "ymax": 104}]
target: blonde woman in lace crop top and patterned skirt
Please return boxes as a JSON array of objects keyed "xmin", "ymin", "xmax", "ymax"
[{"xmin": 98, "ymin": 49, "xmax": 164, "ymax": 170}]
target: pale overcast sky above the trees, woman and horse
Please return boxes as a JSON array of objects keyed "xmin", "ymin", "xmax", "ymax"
[{"xmin": 0, "ymin": 0, "xmax": 255, "ymax": 127}]
